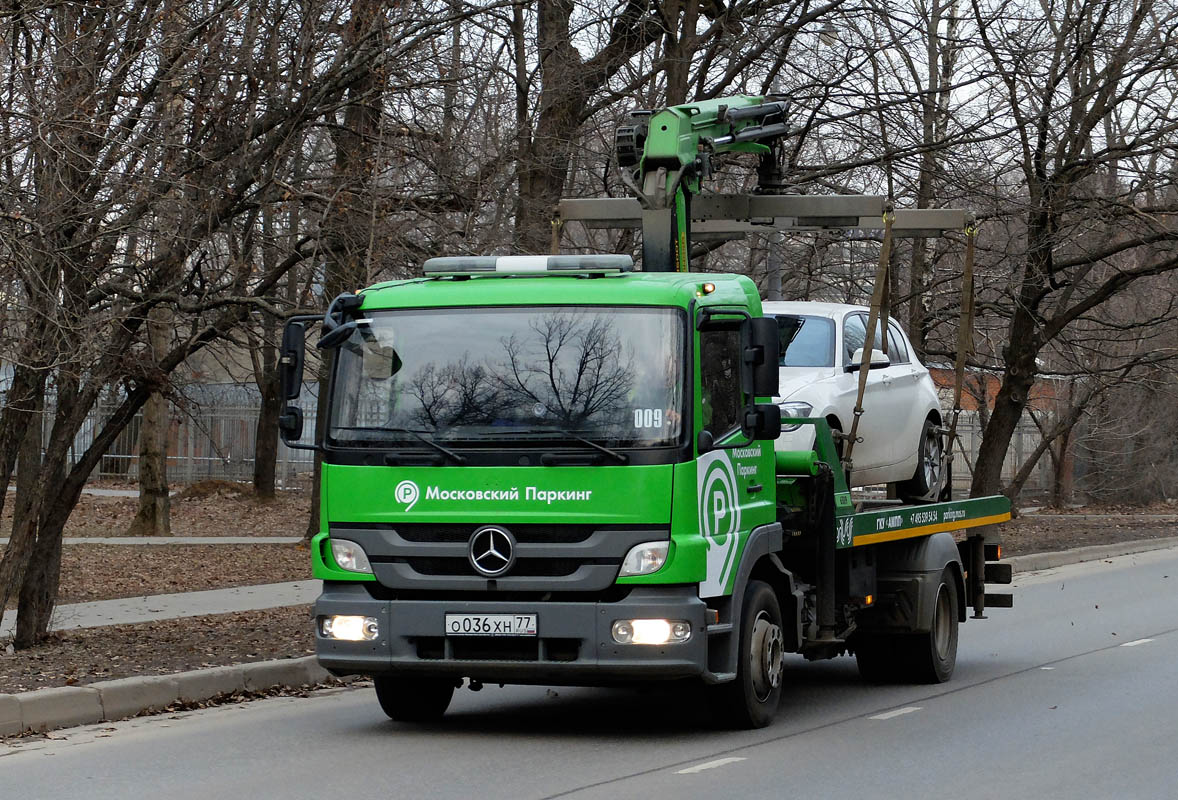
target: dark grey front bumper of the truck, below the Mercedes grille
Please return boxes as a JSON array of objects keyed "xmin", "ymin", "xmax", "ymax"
[{"xmin": 315, "ymin": 581, "xmax": 708, "ymax": 686}]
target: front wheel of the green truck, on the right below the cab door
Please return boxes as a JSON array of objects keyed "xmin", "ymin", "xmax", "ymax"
[{"xmin": 710, "ymin": 581, "xmax": 785, "ymax": 728}]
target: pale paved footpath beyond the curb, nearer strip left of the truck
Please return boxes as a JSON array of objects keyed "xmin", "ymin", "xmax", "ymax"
[{"xmin": 0, "ymin": 581, "xmax": 323, "ymax": 639}]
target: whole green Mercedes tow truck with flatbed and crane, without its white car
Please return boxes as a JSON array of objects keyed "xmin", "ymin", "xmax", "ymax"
[{"xmin": 280, "ymin": 98, "xmax": 1011, "ymax": 727}]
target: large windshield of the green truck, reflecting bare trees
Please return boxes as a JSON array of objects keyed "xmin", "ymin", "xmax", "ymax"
[{"xmin": 330, "ymin": 306, "xmax": 686, "ymax": 447}]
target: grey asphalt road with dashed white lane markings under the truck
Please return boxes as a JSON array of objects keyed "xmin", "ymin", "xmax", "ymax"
[{"xmin": 0, "ymin": 549, "xmax": 1178, "ymax": 800}]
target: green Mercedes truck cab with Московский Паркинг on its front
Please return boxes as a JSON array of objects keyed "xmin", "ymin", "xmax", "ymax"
[{"xmin": 280, "ymin": 257, "xmax": 781, "ymax": 725}]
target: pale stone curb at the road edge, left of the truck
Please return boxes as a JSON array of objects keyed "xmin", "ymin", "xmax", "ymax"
[{"xmin": 0, "ymin": 655, "xmax": 331, "ymax": 736}]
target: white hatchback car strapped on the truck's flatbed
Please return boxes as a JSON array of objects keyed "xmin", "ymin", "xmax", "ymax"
[{"xmin": 762, "ymin": 302, "xmax": 944, "ymax": 502}]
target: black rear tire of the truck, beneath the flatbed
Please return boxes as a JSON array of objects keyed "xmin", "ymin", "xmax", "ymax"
[{"xmin": 854, "ymin": 568, "xmax": 959, "ymax": 683}]
